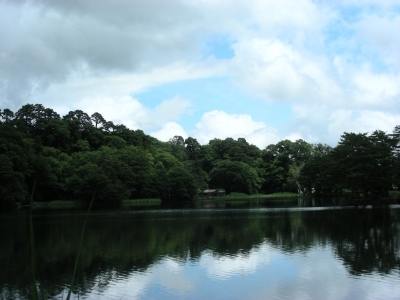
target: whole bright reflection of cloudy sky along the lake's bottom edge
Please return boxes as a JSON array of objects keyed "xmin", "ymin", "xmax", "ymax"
[{"xmin": 79, "ymin": 243, "xmax": 400, "ymax": 300}]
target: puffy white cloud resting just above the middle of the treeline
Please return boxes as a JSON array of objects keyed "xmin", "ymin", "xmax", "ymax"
[{"xmin": 194, "ymin": 110, "xmax": 279, "ymax": 148}]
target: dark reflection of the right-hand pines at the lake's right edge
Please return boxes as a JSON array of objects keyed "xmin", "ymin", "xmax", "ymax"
[{"xmin": 324, "ymin": 208, "xmax": 400, "ymax": 275}]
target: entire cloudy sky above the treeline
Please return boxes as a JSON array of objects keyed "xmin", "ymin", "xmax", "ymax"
[{"xmin": 0, "ymin": 0, "xmax": 400, "ymax": 149}]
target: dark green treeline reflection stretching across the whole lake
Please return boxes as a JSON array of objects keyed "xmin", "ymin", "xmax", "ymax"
[{"xmin": 0, "ymin": 209, "xmax": 400, "ymax": 298}]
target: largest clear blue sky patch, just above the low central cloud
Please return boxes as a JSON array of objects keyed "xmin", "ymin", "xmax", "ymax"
[{"xmin": 133, "ymin": 78, "xmax": 292, "ymax": 131}]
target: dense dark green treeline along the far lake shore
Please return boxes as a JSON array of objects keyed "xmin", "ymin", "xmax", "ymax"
[{"xmin": 0, "ymin": 104, "xmax": 400, "ymax": 206}]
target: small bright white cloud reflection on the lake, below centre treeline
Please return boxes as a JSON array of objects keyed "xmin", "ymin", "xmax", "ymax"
[{"xmin": 199, "ymin": 244, "xmax": 271, "ymax": 280}]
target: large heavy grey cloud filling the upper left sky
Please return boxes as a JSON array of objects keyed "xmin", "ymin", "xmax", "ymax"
[{"xmin": 0, "ymin": 0, "xmax": 225, "ymax": 104}]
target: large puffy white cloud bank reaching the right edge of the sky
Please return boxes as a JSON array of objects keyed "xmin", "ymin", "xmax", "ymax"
[{"xmin": 234, "ymin": 38, "xmax": 400, "ymax": 110}]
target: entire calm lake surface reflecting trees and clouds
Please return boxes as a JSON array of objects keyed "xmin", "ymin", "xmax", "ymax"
[{"xmin": 0, "ymin": 201, "xmax": 400, "ymax": 299}]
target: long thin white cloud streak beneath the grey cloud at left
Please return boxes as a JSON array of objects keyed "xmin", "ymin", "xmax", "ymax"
[{"xmin": 28, "ymin": 62, "xmax": 223, "ymax": 113}]
